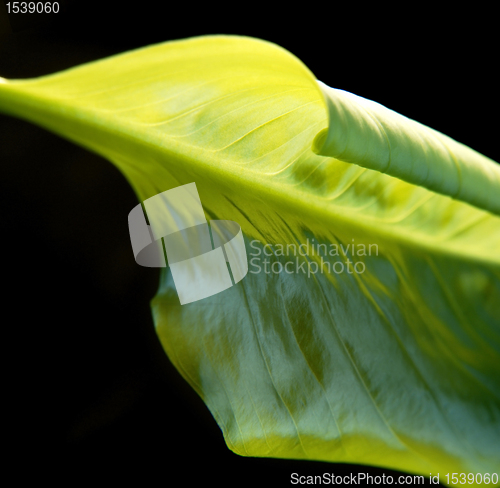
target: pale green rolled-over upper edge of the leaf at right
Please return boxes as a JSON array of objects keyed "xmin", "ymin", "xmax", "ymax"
[{"xmin": 312, "ymin": 82, "xmax": 500, "ymax": 215}]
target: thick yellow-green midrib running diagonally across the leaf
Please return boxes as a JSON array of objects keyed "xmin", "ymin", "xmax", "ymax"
[{"xmin": 0, "ymin": 81, "xmax": 500, "ymax": 267}]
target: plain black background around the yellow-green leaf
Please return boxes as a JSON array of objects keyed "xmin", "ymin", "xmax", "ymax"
[{"xmin": 0, "ymin": 0, "xmax": 500, "ymax": 486}]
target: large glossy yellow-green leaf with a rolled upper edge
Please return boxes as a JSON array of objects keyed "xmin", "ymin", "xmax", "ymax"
[{"xmin": 0, "ymin": 36, "xmax": 500, "ymax": 480}]
